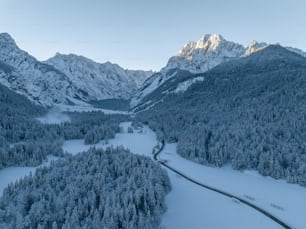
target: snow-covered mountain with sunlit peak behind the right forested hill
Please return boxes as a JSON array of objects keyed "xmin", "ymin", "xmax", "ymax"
[{"xmin": 131, "ymin": 34, "xmax": 306, "ymax": 107}]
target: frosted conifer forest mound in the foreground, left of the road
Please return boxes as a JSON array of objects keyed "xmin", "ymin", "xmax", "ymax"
[{"xmin": 0, "ymin": 148, "xmax": 170, "ymax": 229}]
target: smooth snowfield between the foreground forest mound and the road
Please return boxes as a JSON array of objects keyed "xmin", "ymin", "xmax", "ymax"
[{"xmin": 162, "ymin": 172, "xmax": 282, "ymax": 229}]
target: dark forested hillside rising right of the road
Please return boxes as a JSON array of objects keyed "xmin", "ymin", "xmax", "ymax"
[{"xmin": 138, "ymin": 46, "xmax": 306, "ymax": 186}]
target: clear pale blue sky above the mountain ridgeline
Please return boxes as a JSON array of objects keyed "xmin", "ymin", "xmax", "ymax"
[{"xmin": 0, "ymin": 0, "xmax": 306, "ymax": 70}]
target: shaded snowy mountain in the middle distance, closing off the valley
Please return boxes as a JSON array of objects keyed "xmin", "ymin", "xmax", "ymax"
[{"xmin": 44, "ymin": 53, "xmax": 153, "ymax": 100}]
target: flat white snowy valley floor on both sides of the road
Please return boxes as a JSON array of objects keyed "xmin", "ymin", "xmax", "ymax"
[{"xmin": 0, "ymin": 123, "xmax": 306, "ymax": 229}]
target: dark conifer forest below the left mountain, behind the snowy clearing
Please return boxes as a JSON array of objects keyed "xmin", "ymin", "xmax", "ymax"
[{"xmin": 0, "ymin": 85, "xmax": 127, "ymax": 169}]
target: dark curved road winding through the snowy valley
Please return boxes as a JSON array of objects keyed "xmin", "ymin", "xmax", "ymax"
[{"xmin": 153, "ymin": 140, "xmax": 294, "ymax": 229}]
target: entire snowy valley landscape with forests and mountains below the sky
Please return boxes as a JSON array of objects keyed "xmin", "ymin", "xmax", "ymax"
[{"xmin": 0, "ymin": 33, "xmax": 306, "ymax": 229}]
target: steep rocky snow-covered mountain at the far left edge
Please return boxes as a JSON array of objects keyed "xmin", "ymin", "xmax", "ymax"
[{"xmin": 0, "ymin": 33, "xmax": 82, "ymax": 106}]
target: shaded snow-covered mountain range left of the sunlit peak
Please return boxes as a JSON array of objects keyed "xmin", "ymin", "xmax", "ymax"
[{"xmin": 0, "ymin": 33, "xmax": 152, "ymax": 106}]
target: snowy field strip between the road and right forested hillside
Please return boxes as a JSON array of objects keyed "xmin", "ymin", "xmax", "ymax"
[{"xmin": 160, "ymin": 144, "xmax": 306, "ymax": 229}]
